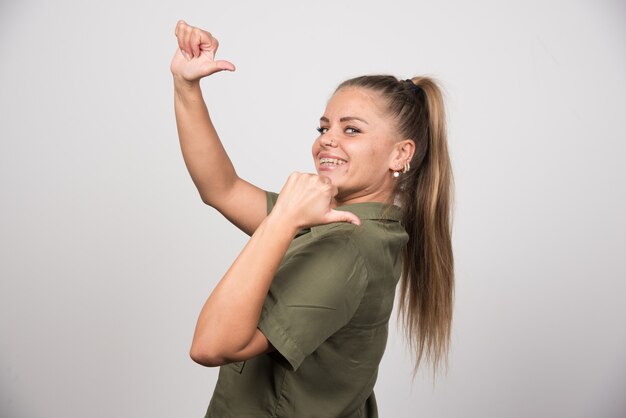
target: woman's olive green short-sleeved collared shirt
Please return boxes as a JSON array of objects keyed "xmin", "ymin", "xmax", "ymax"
[{"xmin": 205, "ymin": 193, "xmax": 408, "ymax": 418}]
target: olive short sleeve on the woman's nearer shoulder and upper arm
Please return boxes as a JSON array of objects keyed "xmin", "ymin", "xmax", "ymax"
[{"xmin": 259, "ymin": 234, "xmax": 367, "ymax": 370}]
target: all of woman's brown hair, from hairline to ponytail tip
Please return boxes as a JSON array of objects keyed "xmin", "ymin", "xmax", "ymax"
[{"xmin": 338, "ymin": 76, "xmax": 454, "ymax": 371}]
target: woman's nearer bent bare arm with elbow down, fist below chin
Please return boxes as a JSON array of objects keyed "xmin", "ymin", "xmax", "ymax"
[{"xmin": 190, "ymin": 173, "xmax": 359, "ymax": 366}]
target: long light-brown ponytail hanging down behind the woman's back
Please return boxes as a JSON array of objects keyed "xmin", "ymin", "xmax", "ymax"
[{"xmin": 399, "ymin": 77, "xmax": 454, "ymax": 370}]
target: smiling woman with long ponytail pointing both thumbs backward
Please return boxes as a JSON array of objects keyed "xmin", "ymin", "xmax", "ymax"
[{"xmin": 171, "ymin": 21, "xmax": 453, "ymax": 417}]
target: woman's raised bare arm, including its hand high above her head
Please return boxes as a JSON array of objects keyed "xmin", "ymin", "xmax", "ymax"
[{"xmin": 171, "ymin": 21, "xmax": 267, "ymax": 235}]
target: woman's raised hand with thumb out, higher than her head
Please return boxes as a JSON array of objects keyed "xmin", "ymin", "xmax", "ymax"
[{"xmin": 170, "ymin": 20, "xmax": 235, "ymax": 83}]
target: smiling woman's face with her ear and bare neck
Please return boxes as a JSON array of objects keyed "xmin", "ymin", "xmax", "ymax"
[{"xmin": 313, "ymin": 87, "xmax": 407, "ymax": 204}]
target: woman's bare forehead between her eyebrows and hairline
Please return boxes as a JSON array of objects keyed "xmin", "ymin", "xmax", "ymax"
[{"xmin": 324, "ymin": 87, "xmax": 386, "ymax": 118}]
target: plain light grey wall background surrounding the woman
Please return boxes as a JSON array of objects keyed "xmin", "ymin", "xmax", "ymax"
[{"xmin": 0, "ymin": 0, "xmax": 626, "ymax": 418}]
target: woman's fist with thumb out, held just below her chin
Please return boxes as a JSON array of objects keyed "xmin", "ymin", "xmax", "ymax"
[{"xmin": 271, "ymin": 173, "xmax": 361, "ymax": 231}]
